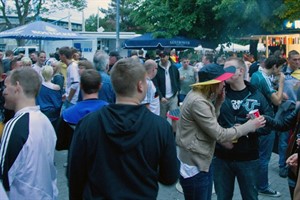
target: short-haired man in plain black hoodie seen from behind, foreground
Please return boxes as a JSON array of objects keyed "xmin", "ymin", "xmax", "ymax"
[{"xmin": 69, "ymin": 58, "xmax": 179, "ymax": 199}]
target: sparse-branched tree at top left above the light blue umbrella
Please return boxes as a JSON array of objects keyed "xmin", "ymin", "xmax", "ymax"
[{"xmin": 0, "ymin": 0, "xmax": 86, "ymax": 28}]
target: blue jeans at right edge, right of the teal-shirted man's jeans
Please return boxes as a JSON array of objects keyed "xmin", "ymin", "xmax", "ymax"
[{"xmin": 278, "ymin": 131, "xmax": 290, "ymax": 168}]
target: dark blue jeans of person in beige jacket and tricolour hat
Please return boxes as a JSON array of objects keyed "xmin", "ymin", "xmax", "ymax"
[{"xmin": 179, "ymin": 167, "xmax": 213, "ymax": 200}]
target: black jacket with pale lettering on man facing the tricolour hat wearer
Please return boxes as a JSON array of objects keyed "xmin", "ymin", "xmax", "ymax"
[{"xmin": 215, "ymin": 82, "xmax": 274, "ymax": 161}]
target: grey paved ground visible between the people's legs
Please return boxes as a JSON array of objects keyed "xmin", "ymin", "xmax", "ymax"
[{"xmin": 55, "ymin": 151, "xmax": 290, "ymax": 200}]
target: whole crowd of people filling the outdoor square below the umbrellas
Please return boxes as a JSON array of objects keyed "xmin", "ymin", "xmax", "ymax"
[{"xmin": 0, "ymin": 47, "xmax": 300, "ymax": 200}]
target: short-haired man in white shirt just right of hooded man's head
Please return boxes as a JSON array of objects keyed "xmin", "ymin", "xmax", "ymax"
[{"xmin": 141, "ymin": 59, "xmax": 160, "ymax": 115}]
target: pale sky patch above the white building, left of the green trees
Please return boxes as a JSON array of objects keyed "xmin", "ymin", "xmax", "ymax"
[{"xmin": 51, "ymin": 0, "xmax": 111, "ymax": 22}]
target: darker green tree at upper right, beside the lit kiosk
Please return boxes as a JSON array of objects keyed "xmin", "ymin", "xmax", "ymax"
[{"xmin": 213, "ymin": 0, "xmax": 283, "ymax": 57}]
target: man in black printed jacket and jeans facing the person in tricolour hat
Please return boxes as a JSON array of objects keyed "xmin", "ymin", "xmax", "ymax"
[{"xmin": 213, "ymin": 58, "xmax": 274, "ymax": 200}]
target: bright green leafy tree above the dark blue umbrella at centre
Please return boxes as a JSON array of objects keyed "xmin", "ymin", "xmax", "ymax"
[{"xmin": 130, "ymin": 0, "xmax": 227, "ymax": 47}]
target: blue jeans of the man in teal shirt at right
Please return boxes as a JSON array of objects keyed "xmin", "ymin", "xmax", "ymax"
[{"xmin": 258, "ymin": 131, "xmax": 275, "ymax": 191}]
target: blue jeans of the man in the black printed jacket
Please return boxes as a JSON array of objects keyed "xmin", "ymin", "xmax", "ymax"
[{"xmin": 213, "ymin": 158, "xmax": 259, "ymax": 200}]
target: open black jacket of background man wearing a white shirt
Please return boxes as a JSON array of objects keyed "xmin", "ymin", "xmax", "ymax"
[{"xmin": 152, "ymin": 62, "xmax": 180, "ymax": 99}]
